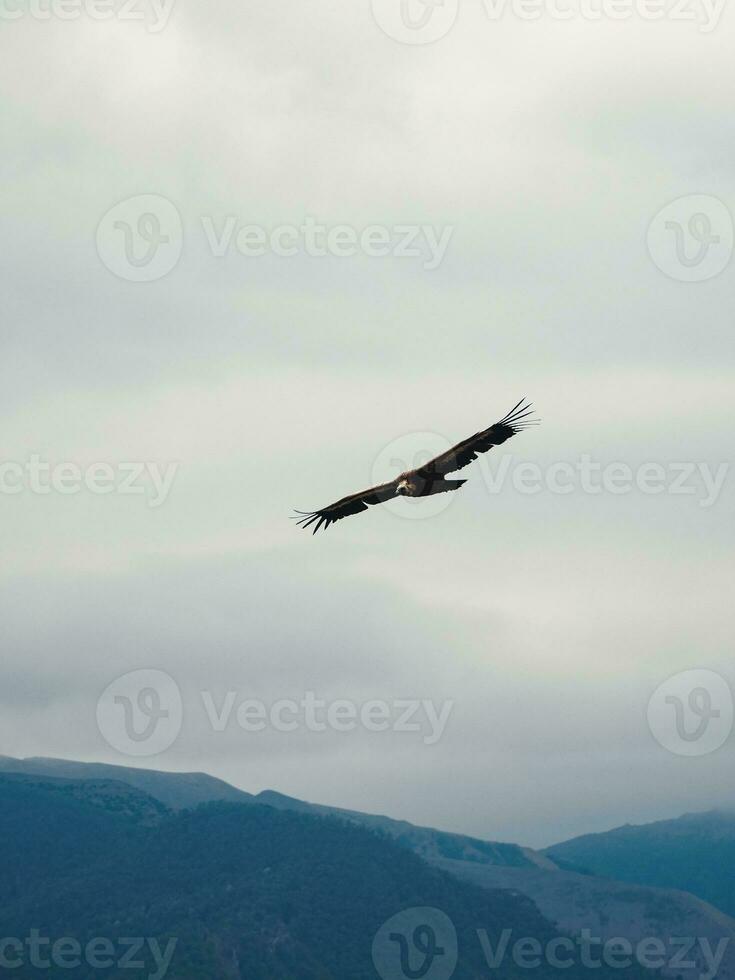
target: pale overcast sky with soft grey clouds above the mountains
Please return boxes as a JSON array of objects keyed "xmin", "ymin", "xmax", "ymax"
[{"xmin": 0, "ymin": 0, "xmax": 735, "ymax": 846}]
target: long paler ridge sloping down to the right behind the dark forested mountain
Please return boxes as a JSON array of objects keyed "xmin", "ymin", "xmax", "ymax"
[{"xmin": 0, "ymin": 760, "xmax": 735, "ymax": 980}]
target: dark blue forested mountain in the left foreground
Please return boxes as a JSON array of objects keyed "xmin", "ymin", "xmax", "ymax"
[{"xmin": 0, "ymin": 773, "xmax": 650, "ymax": 980}]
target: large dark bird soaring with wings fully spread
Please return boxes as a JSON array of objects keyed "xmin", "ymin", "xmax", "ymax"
[{"xmin": 293, "ymin": 398, "xmax": 538, "ymax": 534}]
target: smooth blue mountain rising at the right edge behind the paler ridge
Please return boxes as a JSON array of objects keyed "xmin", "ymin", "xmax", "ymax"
[{"xmin": 545, "ymin": 810, "xmax": 735, "ymax": 916}]
